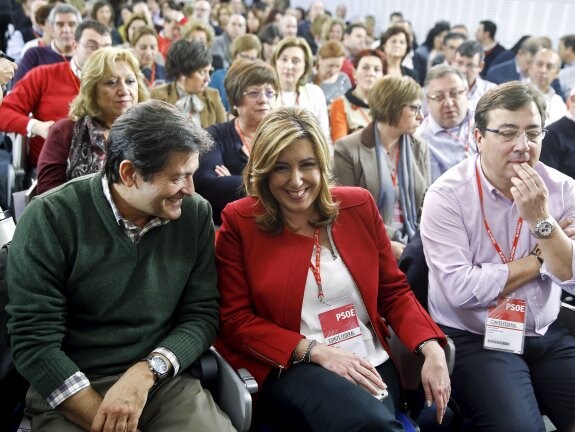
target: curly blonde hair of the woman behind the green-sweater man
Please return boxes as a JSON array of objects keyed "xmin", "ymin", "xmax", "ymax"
[{"xmin": 69, "ymin": 47, "xmax": 149, "ymax": 120}]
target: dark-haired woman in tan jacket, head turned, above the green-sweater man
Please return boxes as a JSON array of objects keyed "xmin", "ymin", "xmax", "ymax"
[{"xmin": 151, "ymin": 39, "xmax": 226, "ymax": 128}]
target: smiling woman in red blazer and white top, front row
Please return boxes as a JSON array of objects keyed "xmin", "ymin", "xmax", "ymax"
[{"xmin": 216, "ymin": 107, "xmax": 450, "ymax": 432}]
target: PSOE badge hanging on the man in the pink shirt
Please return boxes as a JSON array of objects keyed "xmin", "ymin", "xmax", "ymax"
[{"xmin": 483, "ymin": 298, "xmax": 527, "ymax": 354}]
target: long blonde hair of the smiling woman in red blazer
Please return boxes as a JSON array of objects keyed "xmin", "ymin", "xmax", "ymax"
[{"xmin": 243, "ymin": 107, "xmax": 338, "ymax": 234}]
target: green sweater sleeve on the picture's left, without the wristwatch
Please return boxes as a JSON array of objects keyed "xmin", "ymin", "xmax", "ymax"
[{"xmin": 6, "ymin": 198, "xmax": 83, "ymax": 398}]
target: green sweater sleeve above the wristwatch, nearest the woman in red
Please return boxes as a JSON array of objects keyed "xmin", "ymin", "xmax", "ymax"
[{"xmin": 157, "ymin": 197, "xmax": 219, "ymax": 370}]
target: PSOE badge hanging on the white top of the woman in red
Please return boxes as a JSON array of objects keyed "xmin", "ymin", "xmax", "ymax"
[{"xmin": 318, "ymin": 297, "xmax": 367, "ymax": 358}]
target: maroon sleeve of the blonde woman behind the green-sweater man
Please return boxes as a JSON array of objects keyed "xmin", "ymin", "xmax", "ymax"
[{"xmin": 38, "ymin": 119, "xmax": 74, "ymax": 194}]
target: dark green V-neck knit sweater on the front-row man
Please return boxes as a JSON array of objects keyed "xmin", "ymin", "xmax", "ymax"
[{"xmin": 7, "ymin": 174, "xmax": 218, "ymax": 397}]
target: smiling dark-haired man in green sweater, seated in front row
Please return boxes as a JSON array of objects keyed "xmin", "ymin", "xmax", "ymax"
[{"xmin": 7, "ymin": 101, "xmax": 234, "ymax": 432}]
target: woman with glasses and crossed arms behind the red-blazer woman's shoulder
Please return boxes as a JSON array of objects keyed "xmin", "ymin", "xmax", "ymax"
[{"xmin": 194, "ymin": 59, "xmax": 279, "ymax": 225}]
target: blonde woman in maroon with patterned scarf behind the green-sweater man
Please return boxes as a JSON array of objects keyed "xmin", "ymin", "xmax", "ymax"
[{"xmin": 38, "ymin": 48, "xmax": 148, "ymax": 193}]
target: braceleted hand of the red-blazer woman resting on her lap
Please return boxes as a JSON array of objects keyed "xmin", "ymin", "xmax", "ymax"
[{"xmin": 311, "ymin": 343, "xmax": 387, "ymax": 395}]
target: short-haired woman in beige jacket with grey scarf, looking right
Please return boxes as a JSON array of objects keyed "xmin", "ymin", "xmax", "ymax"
[{"xmin": 333, "ymin": 76, "xmax": 431, "ymax": 259}]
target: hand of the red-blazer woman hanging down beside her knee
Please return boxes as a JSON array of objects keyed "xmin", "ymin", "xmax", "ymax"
[{"xmin": 421, "ymin": 341, "xmax": 451, "ymax": 424}]
